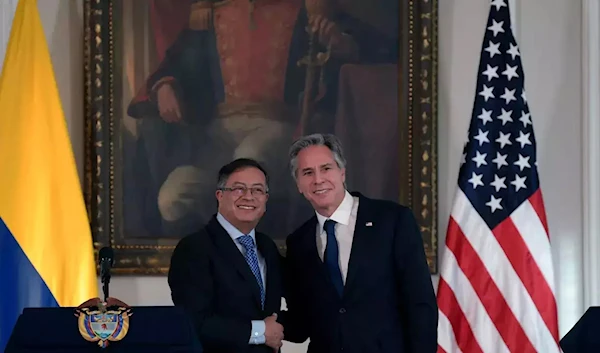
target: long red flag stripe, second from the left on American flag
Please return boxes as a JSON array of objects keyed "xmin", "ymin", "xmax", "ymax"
[{"xmin": 446, "ymin": 217, "xmax": 537, "ymax": 353}]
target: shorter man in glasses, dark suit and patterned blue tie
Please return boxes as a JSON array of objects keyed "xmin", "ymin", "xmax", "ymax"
[{"xmin": 168, "ymin": 159, "xmax": 283, "ymax": 353}]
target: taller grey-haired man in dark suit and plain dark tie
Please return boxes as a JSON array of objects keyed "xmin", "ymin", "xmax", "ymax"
[{"xmin": 284, "ymin": 134, "xmax": 438, "ymax": 353}]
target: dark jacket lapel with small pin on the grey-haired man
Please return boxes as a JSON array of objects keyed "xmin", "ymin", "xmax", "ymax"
[{"xmin": 344, "ymin": 194, "xmax": 374, "ymax": 295}]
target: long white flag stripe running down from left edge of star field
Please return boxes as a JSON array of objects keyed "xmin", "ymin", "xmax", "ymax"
[{"xmin": 450, "ymin": 189, "xmax": 559, "ymax": 353}]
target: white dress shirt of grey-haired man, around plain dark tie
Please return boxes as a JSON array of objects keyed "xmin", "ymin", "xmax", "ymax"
[{"xmin": 315, "ymin": 191, "xmax": 358, "ymax": 284}]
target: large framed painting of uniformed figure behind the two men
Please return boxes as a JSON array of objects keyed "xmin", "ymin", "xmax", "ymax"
[{"xmin": 84, "ymin": 0, "xmax": 437, "ymax": 275}]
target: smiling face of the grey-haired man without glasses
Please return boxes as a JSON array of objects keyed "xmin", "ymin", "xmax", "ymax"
[{"xmin": 296, "ymin": 146, "xmax": 346, "ymax": 217}]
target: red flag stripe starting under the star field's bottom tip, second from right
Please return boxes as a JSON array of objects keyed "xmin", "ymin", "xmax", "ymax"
[{"xmin": 492, "ymin": 209, "xmax": 558, "ymax": 343}]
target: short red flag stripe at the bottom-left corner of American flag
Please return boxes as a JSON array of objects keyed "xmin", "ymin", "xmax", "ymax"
[{"xmin": 438, "ymin": 278, "xmax": 483, "ymax": 353}]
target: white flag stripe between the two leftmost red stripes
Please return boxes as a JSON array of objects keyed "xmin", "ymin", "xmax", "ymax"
[{"xmin": 441, "ymin": 239, "xmax": 510, "ymax": 353}]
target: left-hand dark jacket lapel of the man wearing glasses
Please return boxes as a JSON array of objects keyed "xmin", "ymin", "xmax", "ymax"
[{"xmin": 208, "ymin": 218, "xmax": 260, "ymax": 308}]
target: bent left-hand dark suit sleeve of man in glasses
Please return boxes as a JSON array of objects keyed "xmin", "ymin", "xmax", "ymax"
[{"xmin": 168, "ymin": 235, "xmax": 252, "ymax": 351}]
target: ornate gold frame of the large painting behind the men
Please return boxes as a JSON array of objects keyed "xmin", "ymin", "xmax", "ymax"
[{"xmin": 84, "ymin": 0, "xmax": 438, "ymax": 275}]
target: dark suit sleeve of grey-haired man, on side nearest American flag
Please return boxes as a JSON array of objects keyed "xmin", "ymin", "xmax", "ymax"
[{"xmin": 394, "ymin": 208, "xmax": 438, "ymax": 353}]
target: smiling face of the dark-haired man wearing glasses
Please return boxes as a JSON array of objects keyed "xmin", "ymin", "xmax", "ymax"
[{"xmin": 216, "ymin": 167, "xmax": 269, "ymax": 234}]
